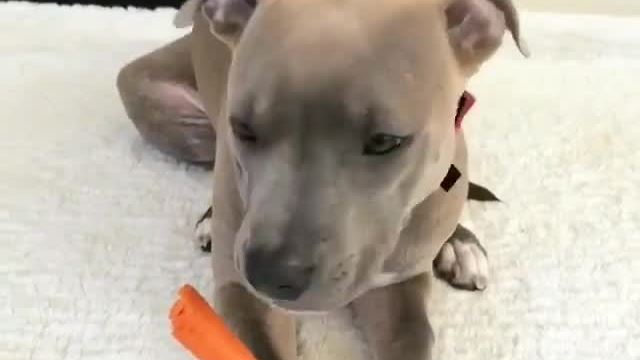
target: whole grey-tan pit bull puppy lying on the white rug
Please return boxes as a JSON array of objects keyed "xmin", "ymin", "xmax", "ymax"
[{"xmin": 118, "ymin": 0, "xmax": 528, "ymax": 360}]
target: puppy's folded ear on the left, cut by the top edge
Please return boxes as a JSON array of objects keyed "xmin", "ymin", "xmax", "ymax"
[{"xmin": 173, "ymin": 0, "xmax": 257, "ymax": 45}]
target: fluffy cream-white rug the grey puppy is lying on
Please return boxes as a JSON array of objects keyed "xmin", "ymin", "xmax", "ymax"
[{"xmin": 0, "ymin": 3, "xmax": 640, "ymax": 360}]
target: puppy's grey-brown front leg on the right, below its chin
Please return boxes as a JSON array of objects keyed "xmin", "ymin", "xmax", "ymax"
[{"xmin": 351, "ymin": 274, "xmax": 434, "ymax": 360}]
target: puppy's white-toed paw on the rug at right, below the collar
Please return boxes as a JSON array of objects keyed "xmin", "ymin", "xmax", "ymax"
[{"xmin": 433, "ymin": 225, "xmax": 489, "ymax": 291}]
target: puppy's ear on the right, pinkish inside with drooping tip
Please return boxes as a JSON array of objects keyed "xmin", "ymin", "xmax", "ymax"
[{"xmin": 445, "ymin": 0, "xmax": 529, "ymax": 67}]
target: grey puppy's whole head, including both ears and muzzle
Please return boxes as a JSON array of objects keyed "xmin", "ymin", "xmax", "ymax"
[{"xmin": 178, "ymin": 0, "xmax": 526, "ymax": 311}]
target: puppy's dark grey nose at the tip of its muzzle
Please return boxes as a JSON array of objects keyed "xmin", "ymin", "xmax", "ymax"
[{"xmin": 245, "ymin": 249, "xmax": 314, "ymax": 301}]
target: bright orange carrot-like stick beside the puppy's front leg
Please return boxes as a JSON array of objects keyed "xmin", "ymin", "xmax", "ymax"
[{"xmin": 169, "ymin": 285, "xmax": 256, "ymax": 360}]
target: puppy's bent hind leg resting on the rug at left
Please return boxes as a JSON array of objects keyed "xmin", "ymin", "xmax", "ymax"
[{"xmin": 117, "ymin": 34, "xmax": 215, "ymax": 165}]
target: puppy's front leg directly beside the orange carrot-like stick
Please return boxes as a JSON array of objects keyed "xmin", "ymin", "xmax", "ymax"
[{"xmin": 216, "ymin": 283, "xmax": 297, "ymax": 360}]
